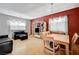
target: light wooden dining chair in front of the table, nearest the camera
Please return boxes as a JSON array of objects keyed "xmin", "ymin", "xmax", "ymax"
[{"xmin": 44, "ymin": 37, "xmax": 60, "ymax": 55}]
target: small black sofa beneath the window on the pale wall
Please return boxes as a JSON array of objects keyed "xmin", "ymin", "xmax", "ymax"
[{"xmin": 14, "ymin": 31, "xmax": 28, "ymax": 40}]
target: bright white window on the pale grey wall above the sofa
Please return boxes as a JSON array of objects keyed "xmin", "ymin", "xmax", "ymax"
[{"xmin": 8, "ymin": 20, "xmax": 26, "ymax": 30}]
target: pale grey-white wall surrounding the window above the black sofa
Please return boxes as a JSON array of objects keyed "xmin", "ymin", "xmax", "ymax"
[{"xmin": 0, "ymin": 14, "xmax": 30, "ymax": 36}]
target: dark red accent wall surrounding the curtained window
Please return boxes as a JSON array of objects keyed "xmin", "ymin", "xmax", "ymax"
[{"xmin": 30, "ymin": 7, "xmax": 79, "ymax": 41}]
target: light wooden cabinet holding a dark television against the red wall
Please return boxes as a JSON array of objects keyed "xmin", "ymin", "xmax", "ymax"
[{"xmin": 32, "ymin": 20, "xmax": 46, "ymax": 37}]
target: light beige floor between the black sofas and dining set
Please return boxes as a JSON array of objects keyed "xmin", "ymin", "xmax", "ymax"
[{"xmin": 11, "ymin": 37, "xmax": 44, "ymax": 55}]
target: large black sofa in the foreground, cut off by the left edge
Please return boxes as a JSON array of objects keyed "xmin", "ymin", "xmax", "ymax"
[{"xmin": 0, "ymin": 35, "xmax": 13, "ymax": 55}]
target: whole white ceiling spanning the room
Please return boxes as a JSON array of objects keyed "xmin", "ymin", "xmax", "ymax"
[{"xmin": 0, "ymin": 3, "xmax": 79, "ymax": 19}]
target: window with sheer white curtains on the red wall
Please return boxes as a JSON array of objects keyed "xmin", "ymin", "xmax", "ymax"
[{"xmin": 49, "ymin": 16, "xmax": 68, "ymax": 34}]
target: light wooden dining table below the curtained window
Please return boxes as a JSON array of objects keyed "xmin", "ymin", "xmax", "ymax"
[{"xmin": 46, "ymin": 34, "xmax": 69, "ymax": 55}]
